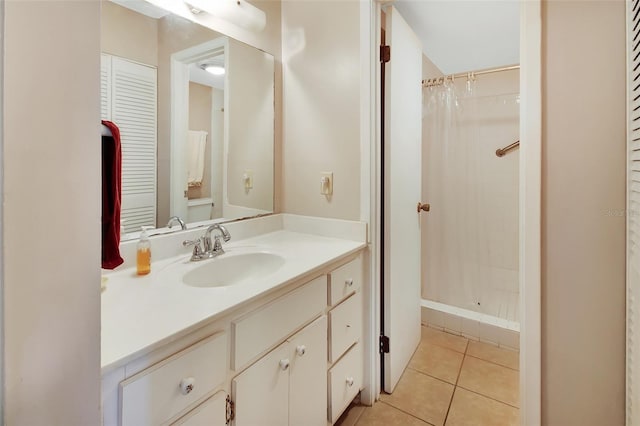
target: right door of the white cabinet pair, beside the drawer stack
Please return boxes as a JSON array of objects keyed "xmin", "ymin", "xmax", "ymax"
[{"xmin": 292, "ymin": 316, "xmax": 327, "ymax": 426}]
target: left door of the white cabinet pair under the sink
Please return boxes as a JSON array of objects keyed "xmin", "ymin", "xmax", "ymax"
[{"xmin": 232, "ymin": 342, "xmax": 288, "ymax": 426}]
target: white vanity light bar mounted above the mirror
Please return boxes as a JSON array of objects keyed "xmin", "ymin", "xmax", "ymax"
[{"xmin": 185, "ymin": 0, "xmax": 267, "ymax": 31}]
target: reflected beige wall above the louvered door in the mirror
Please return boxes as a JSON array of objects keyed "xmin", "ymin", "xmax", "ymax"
[{"xmin": 100, "ymin": 0, "xmax": 158, "ymax": 66}]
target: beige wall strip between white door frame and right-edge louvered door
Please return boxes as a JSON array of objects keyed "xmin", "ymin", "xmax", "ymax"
[{"xmin": 542, "ymin": 1, "xmax": 626, "ymax": 426}]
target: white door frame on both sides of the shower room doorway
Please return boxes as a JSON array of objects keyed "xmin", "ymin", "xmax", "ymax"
[{"xmin": 360, "ymin": 0, "xmax": 542, "ymax": 425}]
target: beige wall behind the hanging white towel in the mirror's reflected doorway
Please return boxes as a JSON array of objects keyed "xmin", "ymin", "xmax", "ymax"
[{"xmin": 188, "ymin": 81, "xmax": 213, "ymax": 199}]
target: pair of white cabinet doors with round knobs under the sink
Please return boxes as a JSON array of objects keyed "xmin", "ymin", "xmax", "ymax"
[{"xmin": 231, "ymin": 315, "xmax": 327, "ymax": 426}]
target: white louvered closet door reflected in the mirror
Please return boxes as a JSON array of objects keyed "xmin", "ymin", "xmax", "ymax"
[{"xmin": 111, "ymin": 57, "xmax": 157, "ymax": 232}]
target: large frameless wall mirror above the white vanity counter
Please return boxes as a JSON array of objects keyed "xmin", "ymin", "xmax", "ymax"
[{"xmin": 102, "ymin": 0, "xmax": 274, "ymax": 240}]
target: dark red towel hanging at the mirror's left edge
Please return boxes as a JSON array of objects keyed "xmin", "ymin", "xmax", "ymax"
[{"xmin": 102, "ymin": 120, "xmax": 124, "ymax": 269}]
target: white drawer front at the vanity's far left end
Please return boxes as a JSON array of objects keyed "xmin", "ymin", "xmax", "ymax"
[{"xmin": 120, "ymin": 333, "xmax": 228, "ymax": 426}]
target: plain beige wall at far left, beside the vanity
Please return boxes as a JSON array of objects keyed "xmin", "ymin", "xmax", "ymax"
[{"xmin": 2, "ymin": 0, "xmax": 101, "ymax": 426}]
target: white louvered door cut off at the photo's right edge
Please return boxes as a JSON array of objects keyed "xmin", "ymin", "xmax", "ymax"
[{"xmin": 626, "ymin": 0, "xmax": 640, "ymax": 425}]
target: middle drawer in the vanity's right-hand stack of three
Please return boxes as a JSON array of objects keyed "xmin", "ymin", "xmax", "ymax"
[{"xmin": 329, "ymin": 291, "xmax": 362, "ymax": 363}]
